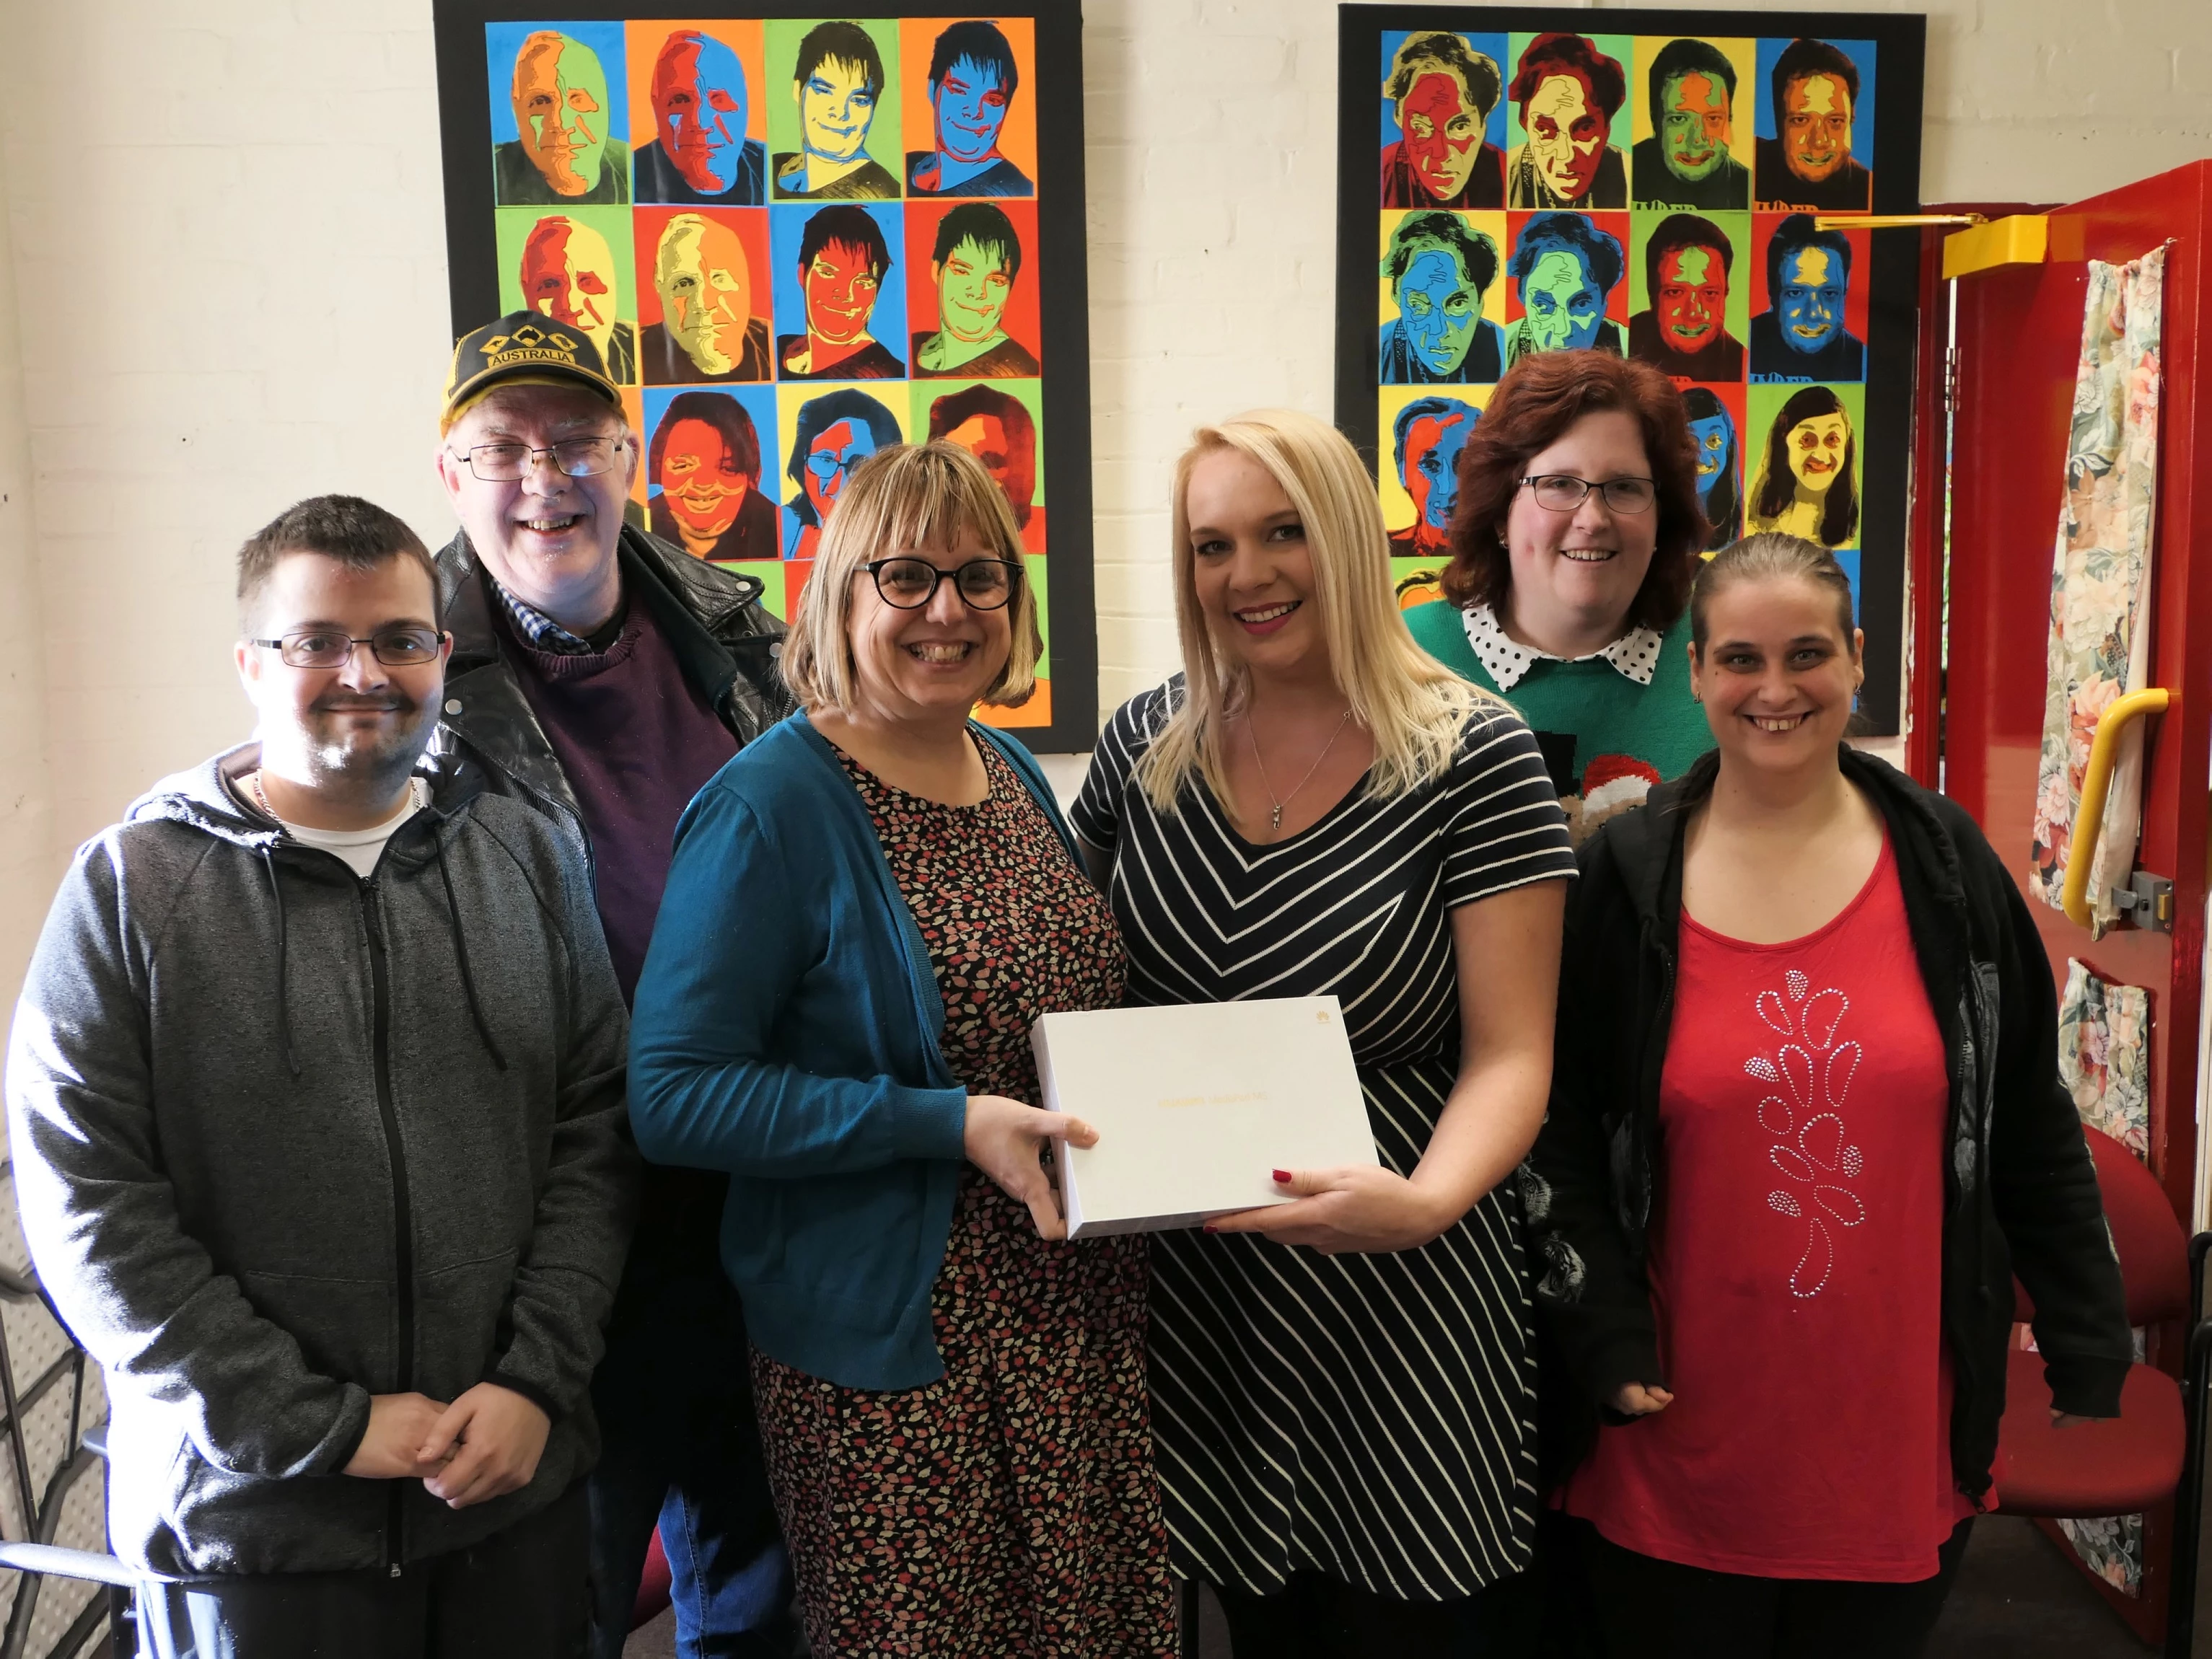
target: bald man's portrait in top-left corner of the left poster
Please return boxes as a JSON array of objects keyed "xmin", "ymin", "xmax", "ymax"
[{"xmin": 484, "ymin": 22, "xmax": 631, "ymax": 208}]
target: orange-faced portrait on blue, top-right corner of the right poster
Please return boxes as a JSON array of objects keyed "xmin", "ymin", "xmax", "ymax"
[{"xmin": 1752, "ymin": 38, "xmax": 1876, "ymax": 212}]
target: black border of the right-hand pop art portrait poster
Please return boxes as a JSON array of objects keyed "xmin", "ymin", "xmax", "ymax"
[{"xmin": 1336, "ymin": 4, "xmax": 1926, "ymax": 736}]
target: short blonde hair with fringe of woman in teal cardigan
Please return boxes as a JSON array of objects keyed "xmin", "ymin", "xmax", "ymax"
[{"xmin": 783, "ymin": 442, "xmax": 1044, "ymax": 715}]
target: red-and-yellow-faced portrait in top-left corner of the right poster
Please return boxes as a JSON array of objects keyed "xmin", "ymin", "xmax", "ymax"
[{"xmin": 1376, "ymin": 29, "xmax": 1509, "ymax": 208}]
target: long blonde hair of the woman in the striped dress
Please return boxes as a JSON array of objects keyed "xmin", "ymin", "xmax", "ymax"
[{"xmin": 1137, "ymin": 409, "xmax": 1506, "ymax": 811}]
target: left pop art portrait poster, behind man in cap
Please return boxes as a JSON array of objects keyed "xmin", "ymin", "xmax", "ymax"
[{"xmin": 436, "ymin": 0, "xmax": 1097, "ymax": 752}]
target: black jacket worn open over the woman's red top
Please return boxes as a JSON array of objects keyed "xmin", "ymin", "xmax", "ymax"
[{"xmin": 1524, "ymin": 748, "xmax": 2135, "ymax": 1502}]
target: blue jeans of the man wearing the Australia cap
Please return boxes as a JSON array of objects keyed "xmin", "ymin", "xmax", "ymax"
[{"xmin": 591, "ymin": 1269, "xmax": 805, "ymax": 1659}]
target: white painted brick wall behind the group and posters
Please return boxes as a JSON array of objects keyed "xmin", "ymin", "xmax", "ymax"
[{"xmin": 0, "ymin": 0, "xmax": 2212, "ymax": 991}]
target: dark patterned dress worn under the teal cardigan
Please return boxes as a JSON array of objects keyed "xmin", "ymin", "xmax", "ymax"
[{"xmin": 752, "ymin": 743, "xmax": 1177, "ymax": 1659}]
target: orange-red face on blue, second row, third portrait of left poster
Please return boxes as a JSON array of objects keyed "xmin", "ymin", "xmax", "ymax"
[{"xmin": 768, "ymin": 201, "xmax": 907, "ymax": 382}]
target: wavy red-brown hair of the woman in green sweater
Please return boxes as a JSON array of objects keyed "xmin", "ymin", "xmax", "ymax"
[{"xmin": 1444, "ymin": 352, "xmax": 1708, "ymax": 633}]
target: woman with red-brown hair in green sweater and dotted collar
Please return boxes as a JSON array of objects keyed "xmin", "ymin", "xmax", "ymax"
[{"xmin": 1405, "ymin": 352, "xmax": 1712, "ymax": 842}]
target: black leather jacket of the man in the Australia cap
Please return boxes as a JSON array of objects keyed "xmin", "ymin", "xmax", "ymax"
[{"xmin": 424, "ymin": 524, "xmax": 792, "ymax": 854}]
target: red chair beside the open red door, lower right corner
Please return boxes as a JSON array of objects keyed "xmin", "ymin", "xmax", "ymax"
[{"xmin": 1998, "ymin": 1126, "xmax": 2212, "ymax": 1659}]
